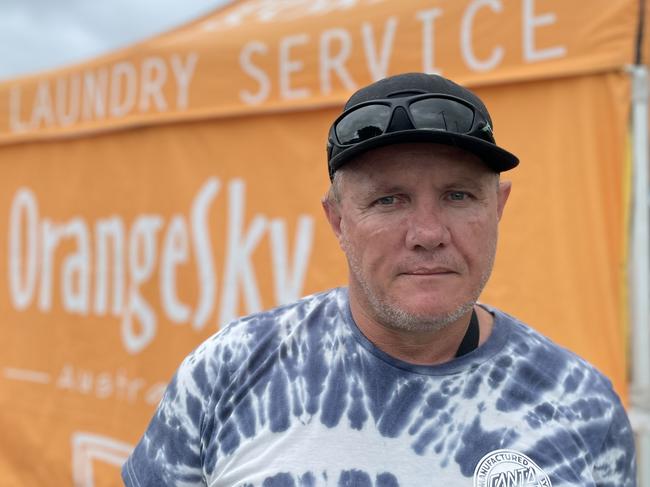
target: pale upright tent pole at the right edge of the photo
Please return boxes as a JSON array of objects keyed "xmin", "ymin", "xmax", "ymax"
[{"xmin": 629, "ymin": 65, "xmax": 650, "ymax": 487}]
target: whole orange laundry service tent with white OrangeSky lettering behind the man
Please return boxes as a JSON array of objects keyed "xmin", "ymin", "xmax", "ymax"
[{"xmin": 0, "ymin": 0, "xmax": 639, "ymax": 487}]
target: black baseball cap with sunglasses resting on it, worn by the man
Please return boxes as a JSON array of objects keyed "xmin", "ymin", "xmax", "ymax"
[{"xmin": 327, "ymin": 73, "xmax": 519, "ymax": 180}]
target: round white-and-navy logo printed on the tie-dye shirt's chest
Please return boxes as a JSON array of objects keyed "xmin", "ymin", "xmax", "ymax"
[{"xmin": 474, "ymin": 450, "xmax": 552, "ymax": 487}]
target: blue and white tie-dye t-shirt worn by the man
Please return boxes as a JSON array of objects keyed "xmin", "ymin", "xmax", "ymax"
[{"xmin": 122, "ymin": 288, "xmax": 636, "ymax": 487}]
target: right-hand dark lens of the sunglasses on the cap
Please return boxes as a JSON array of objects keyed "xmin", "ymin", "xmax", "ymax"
[{"xmin": 409, "ymin": 98, "xmax": 474, "ymax": 134}]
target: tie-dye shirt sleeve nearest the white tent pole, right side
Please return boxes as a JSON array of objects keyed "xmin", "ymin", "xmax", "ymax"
[{"xmin": 593, "ymin": 397, "xmax": 637, "ymax": 487}]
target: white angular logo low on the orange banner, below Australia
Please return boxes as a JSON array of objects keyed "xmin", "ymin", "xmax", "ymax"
[{"xmin": 71, "ymin": 431, "xmax": 133, "ymax": 487}]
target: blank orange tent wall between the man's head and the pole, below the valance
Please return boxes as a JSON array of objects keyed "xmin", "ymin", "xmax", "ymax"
[{"xmin": 480, "ymin": 73, "xmax": 630, "ymax": 397}]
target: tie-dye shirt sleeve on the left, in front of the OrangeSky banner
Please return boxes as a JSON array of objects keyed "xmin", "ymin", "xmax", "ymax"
[{"xmin": 122, "ymin": 349, "xmax": 211, "ymax": 487}]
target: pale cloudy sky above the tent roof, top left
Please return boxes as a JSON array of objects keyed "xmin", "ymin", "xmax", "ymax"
[{"xmin": 0, "ymin": 0, "xmax": 231, "ymax": 80}]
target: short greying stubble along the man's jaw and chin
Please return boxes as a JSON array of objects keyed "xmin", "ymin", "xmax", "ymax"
[{"xmin": 342, "ymin": 236, "xmax": 496, "ymax": 332}]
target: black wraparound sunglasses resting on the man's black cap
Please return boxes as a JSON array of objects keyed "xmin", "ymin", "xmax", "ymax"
[{"xmin": 330, "ymin": 94, "xmax": 495, "ymax": 147}]
